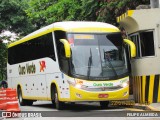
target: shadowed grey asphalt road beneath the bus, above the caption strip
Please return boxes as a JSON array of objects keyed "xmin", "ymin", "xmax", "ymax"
[{"xmin": 21, "ymin": 101, "xmax": 134, "ymax": 113}]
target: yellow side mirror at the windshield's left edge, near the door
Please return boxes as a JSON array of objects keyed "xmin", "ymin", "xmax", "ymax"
[{"xmin": 60, "ymin": 39, "xmax": 71, "ymax": 58}]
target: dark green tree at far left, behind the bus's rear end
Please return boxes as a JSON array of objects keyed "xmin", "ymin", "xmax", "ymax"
[{"xmin": 0, "ymin": 0, "xmax": 34, "ymax": 80}]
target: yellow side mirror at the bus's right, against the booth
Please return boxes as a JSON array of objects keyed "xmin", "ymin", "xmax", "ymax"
[{"xmin": 123, "ymin": 39, "xmax": 136, "ymax": 58}]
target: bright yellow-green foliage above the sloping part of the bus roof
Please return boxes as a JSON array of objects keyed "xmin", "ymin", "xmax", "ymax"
[{"xmin": 26, "ymin": 0, "xmax": 81, "ymax": 29}]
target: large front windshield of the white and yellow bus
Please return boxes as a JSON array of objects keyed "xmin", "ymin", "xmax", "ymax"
[{"xmin": 68, "ymin": 33, "xmax": 128, "ymax": 80}]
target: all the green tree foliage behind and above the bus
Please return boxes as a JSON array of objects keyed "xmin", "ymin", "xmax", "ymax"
[{"xmin": 0, "ymin": 0, "xmax": 150, "ymax": 79}]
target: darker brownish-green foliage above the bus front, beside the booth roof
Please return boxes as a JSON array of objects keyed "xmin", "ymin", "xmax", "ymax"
[{"xmin": 82, "ymin": 0, "xmax": 149, "ymax": 25}]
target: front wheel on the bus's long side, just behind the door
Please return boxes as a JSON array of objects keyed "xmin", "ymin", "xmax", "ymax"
[{"xmin": 54, "ymin": 89, "xmax": 64, "ymax": 110}]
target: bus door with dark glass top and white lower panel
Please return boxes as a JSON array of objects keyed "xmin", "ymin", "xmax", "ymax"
[{"xmin": 54, "ymin": 31, "xmax": 70, "ymax": 98}]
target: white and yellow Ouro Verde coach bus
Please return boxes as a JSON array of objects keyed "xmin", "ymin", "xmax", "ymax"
[{"xmin": 7, "ymin": 21, "xmax": 135, "ymax": 110}]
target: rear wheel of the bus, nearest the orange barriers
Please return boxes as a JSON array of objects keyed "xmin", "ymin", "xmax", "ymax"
[{"xmin": 18, "ymin": 88, "xmax": 33, "ymax": 106}]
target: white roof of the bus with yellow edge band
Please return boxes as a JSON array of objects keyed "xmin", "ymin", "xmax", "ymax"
[{"xmin": 8, "ymin": 21, "xmax": 119, "ymax": 48}]
